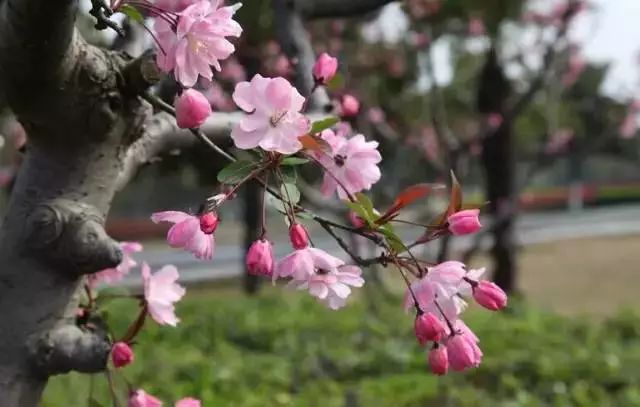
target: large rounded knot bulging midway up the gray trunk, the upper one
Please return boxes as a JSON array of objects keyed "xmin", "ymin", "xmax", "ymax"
[{"xmin": 27, "ymin": 199, "xmax": 122, "ymax": 276}]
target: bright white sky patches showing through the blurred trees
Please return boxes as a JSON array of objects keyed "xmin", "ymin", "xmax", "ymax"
[{"xmin": 364, "ymin": 0, "xmax": 640, "ymax": 99}]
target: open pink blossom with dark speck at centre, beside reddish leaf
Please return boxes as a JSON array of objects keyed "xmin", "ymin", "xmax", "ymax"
[{"xmin": 314, "ymin": 130, "xmax": 382, "ymax": 199}]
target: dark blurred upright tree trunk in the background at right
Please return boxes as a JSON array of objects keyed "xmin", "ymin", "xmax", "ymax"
[{"xmin": 478, "ymin": 49, "xmax": 516, "ymax": 292}]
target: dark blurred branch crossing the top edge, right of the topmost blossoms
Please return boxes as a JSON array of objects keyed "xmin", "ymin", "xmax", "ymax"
[{"xmin": 296, "ymin": 0, "xmax": 394, "ymax": 19}]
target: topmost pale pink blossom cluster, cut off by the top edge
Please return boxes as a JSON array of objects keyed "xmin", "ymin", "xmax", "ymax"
[{"xmin": 154, "ymin": 0, "xmax": 242, "ymax": 87}]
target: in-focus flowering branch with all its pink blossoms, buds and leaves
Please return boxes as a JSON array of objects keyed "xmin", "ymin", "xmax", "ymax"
[{"xmin": 70, "ymin": 0, "xmax": 507, "ymax": 407}]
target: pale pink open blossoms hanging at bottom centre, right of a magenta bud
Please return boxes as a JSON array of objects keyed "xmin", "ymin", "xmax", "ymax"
[{"xmin": 273, "ymin": 247, "xmax": 364, "ymax": 310}]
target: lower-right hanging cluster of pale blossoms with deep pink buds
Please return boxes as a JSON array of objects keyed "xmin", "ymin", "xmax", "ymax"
[{"xmin": 404, "ymin": 261, "xmax": 507, "ymax": 374}]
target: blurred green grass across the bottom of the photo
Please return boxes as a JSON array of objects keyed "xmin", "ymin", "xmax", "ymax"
[{"xmin": 43, "ymin": 288, "xmax": 640, "ymax": 407}]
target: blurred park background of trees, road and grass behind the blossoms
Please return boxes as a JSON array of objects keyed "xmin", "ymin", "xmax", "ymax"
[{"xmin": 0, "ymin": 0, "xmax": 640, "ymax": 406}]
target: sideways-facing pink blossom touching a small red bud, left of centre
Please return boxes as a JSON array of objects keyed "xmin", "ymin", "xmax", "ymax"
[{"xmin": 151, "ymin": 211, "xmax": 215, "ymax": 260}]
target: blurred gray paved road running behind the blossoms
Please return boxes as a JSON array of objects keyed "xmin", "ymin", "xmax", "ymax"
[{"xmin": 119, "ymin": 205, "xmax": 640, "ymax": 286}]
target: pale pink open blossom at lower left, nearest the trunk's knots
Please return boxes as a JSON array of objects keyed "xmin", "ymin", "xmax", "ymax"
[{"xmin": 142, "ymin": 263, "xmax": 185, "ymax": 326}]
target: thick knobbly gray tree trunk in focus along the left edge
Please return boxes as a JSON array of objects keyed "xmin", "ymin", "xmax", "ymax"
[{"xmin": 0, "ymin": 0, "xmax": 161, "ymax": 407}]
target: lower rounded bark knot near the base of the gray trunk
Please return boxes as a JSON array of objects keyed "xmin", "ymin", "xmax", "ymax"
[{"xmin": 29, "ymin": 325, "xmax": 111, "ymax": 377}]
